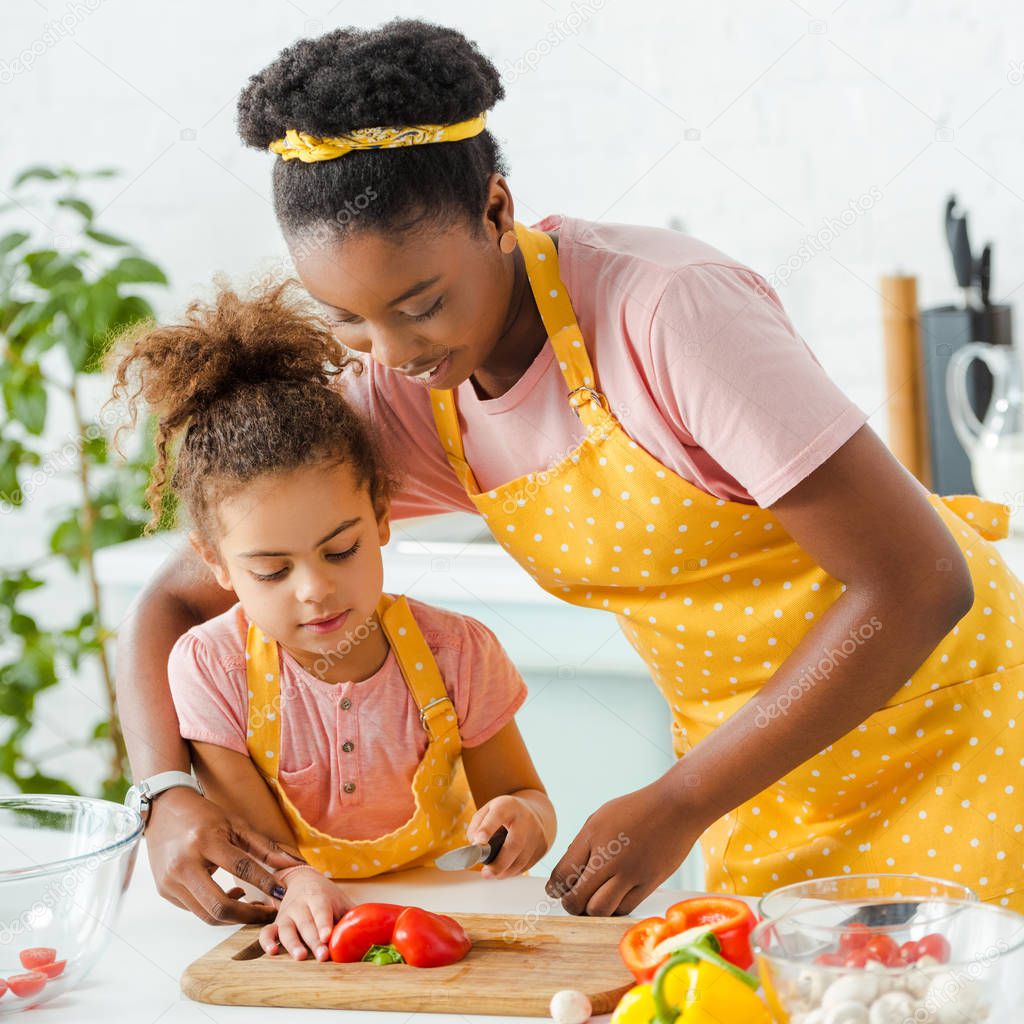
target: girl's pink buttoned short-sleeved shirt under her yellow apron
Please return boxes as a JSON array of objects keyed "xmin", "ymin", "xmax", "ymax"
[{"xmin": 168, "ymin": 599, "xmax": 526, "ymax": 840}]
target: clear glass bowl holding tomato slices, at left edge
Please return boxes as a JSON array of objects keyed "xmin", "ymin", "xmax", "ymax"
[{"xmin": 0, "ymin": 795, "xmax": 142, "ymax": 1017}]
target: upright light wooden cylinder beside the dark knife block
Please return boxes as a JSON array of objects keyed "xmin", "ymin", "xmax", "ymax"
[{"xmin": 882, "ymin": 274, "xmax": 932, "ymax": 487}]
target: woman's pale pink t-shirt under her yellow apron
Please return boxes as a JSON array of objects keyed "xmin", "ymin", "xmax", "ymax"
[{"xmin": 343, "ymin": 216, "xmax": 867, "ymax": 518}]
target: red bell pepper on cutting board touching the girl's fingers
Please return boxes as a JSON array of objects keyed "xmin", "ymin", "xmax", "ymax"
[{"xmin": 329, "ymin": 903, "xmax": 472, "ymax": 967}]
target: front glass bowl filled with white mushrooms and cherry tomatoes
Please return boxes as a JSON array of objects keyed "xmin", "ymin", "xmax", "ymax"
[{"xmin": 751, "ymin": 898, "xmax": 1024, "ymax": 1024}]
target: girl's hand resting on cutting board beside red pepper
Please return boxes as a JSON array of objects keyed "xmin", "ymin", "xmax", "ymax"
[{"xmin": 259, "ymin": 865, "xmax": 353, "ymax": 961}]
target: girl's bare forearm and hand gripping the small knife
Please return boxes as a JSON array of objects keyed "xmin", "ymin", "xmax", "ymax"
[{"xmin": 462, "ymin": 720, "xmax": 557, "ymax": 879}]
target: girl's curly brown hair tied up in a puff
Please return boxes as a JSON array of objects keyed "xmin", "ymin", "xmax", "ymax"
[{"xmin": 104, "ymin": 282, "xmax": 391, "ymax": 543}]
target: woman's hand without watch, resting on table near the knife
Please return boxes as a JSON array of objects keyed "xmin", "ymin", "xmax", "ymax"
[{"xmin": 546, "ymin": 772, "xmax": 710, "ymax": 918}]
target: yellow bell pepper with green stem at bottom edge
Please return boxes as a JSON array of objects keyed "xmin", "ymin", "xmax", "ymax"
[{"xmin": 611, "ymin": 937, "xmax": 771, "ymax": 1024}]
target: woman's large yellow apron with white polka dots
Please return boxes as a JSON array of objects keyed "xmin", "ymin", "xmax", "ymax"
[{"xmin": 431, "ymin": 224, "xmax": 1024, "ymax": 910}]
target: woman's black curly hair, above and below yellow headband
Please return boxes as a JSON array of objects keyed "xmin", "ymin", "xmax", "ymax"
[{"xmin": 238, "ymin": 18, "xmax": 507, "ymax": 243}]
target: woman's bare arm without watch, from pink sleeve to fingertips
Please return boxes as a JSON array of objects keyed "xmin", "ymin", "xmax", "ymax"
[{"xmin": 548, "ymin": 427, "xmax": 974, "ymax": 914}]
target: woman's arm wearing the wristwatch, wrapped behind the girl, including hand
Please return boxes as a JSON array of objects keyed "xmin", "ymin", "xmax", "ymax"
[{"xmin": 117, "ymin": 545, "xmax": 296, "ymax": 924}]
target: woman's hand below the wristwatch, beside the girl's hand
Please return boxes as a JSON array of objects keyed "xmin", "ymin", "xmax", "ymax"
[{"xmin": 145, "ymin": 786, "xmax": 303, "ymax": 925}]
